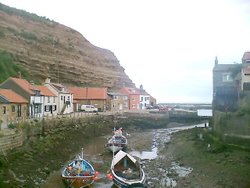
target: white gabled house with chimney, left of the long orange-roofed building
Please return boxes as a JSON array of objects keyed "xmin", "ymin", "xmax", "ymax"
[{"xmin": 44, "ymin": 78, "xmax": 74, "ymax": 114}]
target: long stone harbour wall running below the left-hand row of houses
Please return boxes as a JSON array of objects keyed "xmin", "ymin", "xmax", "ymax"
[{"xmin": 0, "ymin": 113, "xmax": 169, "ymax": 152}]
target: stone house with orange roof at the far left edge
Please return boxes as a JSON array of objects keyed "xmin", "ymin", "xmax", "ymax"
[{"xmin": 0, "ymin": 89, "xmax": 28, "ymax": 128}]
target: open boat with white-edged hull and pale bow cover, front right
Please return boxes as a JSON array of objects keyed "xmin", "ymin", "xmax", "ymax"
[{"xmin": 111, "ymin": 150, "xmax": 146, "ymax": 188}]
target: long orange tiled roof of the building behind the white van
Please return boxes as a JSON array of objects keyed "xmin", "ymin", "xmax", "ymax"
[{"xmin": 68, "ymin": 87, "xmax": 107, "ymax": 100}]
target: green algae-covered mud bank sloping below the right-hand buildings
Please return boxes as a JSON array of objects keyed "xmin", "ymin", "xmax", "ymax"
[{"xmin": 167, "ymin": 130, "xmax": 250, "ymax": 187}]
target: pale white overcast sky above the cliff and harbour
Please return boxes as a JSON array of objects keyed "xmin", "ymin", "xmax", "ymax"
[{"xmin": 0, "ymin": 0, "xmax": 250, "ymax": 103}]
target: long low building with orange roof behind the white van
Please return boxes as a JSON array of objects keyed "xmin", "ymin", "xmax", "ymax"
[{"xmin": 69, "ymin": 87, "xmax": 107, "ymax": 112}]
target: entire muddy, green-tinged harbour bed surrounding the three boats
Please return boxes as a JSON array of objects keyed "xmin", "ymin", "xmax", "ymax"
[{"xmin": 3, "ymin": 114, "xmax": 250, "ymax": 188}]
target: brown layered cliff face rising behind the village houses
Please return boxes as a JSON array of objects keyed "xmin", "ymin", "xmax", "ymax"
[{"xmin": 0, "ymin": 3, "xmax": 134, "ymax": 89}]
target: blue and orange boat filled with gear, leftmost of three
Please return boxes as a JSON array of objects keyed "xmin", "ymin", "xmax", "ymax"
[{"xmin": 61, "ymin": 149, "xmax": 98, "ymax": 187}]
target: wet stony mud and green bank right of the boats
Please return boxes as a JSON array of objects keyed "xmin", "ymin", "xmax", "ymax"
[{"xmin": 119, "ymin": 124, "xmax": 250, "ymax": 188}]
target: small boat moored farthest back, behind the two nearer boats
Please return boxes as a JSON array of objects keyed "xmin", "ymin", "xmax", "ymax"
[{"xmin": 105, "ymin": 128, "xmax": 128, "ymax": 153}]
